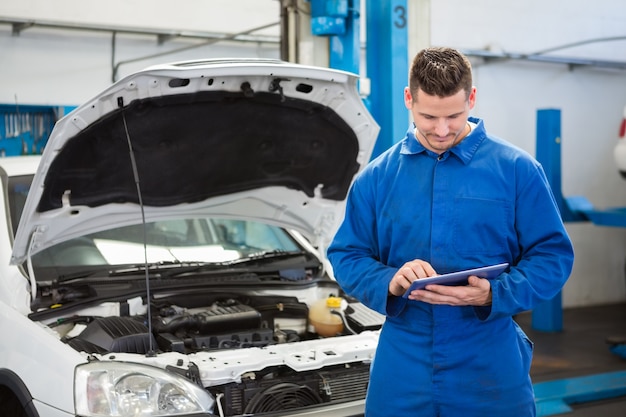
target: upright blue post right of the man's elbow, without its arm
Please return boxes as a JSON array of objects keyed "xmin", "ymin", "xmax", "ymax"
[{"xmin": 532, "ymin": 109, "xmax": 567, "ymax": 332}]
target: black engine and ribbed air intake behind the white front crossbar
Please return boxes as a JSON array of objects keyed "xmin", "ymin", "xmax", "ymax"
[{"xmin": 60, "ymin": 297, "xmax": 308, "ymax": 354}]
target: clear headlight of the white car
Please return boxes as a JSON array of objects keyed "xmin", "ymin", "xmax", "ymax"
[{"xmin": 74, "ymin": 361, "xmax": 215, "ymax": 417}]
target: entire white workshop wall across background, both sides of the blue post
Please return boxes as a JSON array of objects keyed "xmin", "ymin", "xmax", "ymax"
[{"xmin": 0, "ymin": 0, "xmax": 626, "ymax": 306}]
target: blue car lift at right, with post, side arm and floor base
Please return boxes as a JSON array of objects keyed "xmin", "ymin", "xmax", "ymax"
[{"xmin": 532, "ymin": 109, "xmax": 626, "ymax": 416}]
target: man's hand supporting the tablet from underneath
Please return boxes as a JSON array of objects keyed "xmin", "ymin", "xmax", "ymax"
[{"xmin": 408, "ymin": 275, "xmax": 491, "ymax": 306}]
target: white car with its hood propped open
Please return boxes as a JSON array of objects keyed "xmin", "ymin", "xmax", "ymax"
[{"xmin": 0, "ymin": 59, "xmax": 384, "ymax": 417}]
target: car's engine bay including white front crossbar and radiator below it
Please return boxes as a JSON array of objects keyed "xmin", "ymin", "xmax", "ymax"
[{"xmin": 41, "ymin": 285, "xmax": 384, "ymax": 417}]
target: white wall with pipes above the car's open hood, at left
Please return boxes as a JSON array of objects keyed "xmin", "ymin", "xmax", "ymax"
[{"xmin": 0, "ymin": 0, "xmax": 280, "ymax": 105}]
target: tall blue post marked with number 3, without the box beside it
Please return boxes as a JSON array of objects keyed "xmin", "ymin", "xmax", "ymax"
[{"xmin": 365, "ymin": 0, "xmax": 409, "ymax": 158}]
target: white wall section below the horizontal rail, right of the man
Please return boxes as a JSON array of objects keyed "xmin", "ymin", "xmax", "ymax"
[{"xmin": 474, "ymin": 63, "xmax": 626, "ymax": 306}]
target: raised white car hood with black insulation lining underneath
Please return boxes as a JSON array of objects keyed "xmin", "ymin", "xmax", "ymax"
[{"xmin": 11, "ymin": 59, "xmax": 379, "ymax": 264}]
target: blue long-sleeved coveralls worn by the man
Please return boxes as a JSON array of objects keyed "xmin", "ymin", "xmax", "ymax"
[{"xmin": 328, "ymin": 118, "xmax": 574, "ymax": 417}]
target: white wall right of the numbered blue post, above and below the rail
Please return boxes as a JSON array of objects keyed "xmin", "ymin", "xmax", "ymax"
[{"xmin": 430, "ymin": 0, "xmax": 626, "ymax": 306}]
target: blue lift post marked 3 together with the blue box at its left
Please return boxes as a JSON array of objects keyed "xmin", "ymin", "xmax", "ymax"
[{"xmin": 310, "ymin": 0, "xmax": 409, "ymax": 158}]
